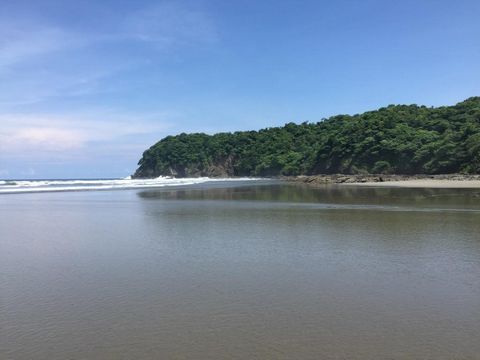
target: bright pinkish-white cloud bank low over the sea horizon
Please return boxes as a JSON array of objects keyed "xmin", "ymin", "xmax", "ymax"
[{"xmin": 0, "ymin": 110, "xmax": 174, "ymax": 159}]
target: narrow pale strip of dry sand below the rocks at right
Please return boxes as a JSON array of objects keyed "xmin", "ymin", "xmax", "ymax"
[{"xmin": 344, "ymin": 179, "xmax": 480, "ymax": 189}]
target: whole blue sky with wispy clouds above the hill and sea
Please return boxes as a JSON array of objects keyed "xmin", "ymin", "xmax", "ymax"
[{"xmin": 0, "ymin": 0, "xmax": 480, "ymax": 179}]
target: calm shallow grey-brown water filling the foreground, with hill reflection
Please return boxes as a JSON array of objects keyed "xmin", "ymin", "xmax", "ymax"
[{"xmin": 0, "ymin": 183, "xmax": 480, "ymax": 359}]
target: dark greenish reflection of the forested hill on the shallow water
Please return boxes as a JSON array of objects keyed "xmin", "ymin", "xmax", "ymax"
[{"xmin": 138, "ymin": 183, "xmax": 480, "ymax": 210}]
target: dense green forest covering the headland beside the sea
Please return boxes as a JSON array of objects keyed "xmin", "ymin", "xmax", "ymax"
[{"xmin": 134, "ymin": 97, "xmax": 480, "ymax": 177}]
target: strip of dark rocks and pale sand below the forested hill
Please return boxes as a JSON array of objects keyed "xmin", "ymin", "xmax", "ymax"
[{"xmin": 282, "ymin": 174, "xmax": 480, "ymax": 189}]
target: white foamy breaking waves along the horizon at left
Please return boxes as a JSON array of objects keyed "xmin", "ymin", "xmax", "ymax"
[{"xmin": 0, "ymin": 176, "xmax": 259, "ymax": 194}]
